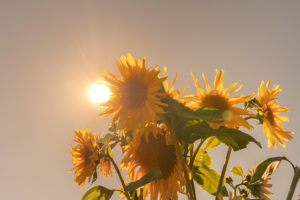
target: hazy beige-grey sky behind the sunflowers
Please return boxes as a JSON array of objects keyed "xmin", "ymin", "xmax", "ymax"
[{"xmin": 0, "ymin": 0, "xmax": 300, "ymax": 200}]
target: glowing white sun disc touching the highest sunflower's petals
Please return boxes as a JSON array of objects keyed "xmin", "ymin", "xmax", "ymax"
[{"xmin": 89, "ymin": 83, "xmax": 111, "ymax": 103}]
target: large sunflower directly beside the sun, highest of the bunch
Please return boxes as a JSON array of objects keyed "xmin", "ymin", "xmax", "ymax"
[{"xmin": 99, "ymin": 54, "xmax": 167, "ymax": 130}]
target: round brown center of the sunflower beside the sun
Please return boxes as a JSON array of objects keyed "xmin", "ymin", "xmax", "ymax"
[{"xmin": 121, "ymin": 79, "xmax": 147, "ymax": 109}]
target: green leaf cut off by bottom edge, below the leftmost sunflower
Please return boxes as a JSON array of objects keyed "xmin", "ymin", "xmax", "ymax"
[{"xmin": 81, "ymin": 185, "xmax": 114, "ymax": 200}]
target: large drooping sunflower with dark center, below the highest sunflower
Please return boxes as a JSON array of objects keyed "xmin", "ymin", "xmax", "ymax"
[{"xmin": 122, "ymin": 125, "xmax": 185, "ymax": 200}]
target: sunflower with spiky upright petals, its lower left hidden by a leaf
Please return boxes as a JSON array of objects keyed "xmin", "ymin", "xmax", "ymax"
[{"xmin": 189, "ymin": 70, "xmax": 252, "ymax": 129}]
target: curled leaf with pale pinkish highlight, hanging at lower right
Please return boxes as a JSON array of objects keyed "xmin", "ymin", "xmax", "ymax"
[{"xmin": 250, "ymin": 156, "xmax": 286, "ymax": 183}]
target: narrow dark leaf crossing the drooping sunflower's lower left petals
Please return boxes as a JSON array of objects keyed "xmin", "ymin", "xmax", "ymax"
[{"xmin": 125, "ymin": 168, "xmax": 162, "ymax": 191}]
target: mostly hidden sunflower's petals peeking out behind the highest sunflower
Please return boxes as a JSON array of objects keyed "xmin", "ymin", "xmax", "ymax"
[{"xmin": 163, "ymin": 67, "xmax": 188, "ymax": 103}]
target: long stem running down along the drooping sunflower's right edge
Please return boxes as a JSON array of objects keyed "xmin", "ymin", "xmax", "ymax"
[{"xmin": 170, "ymin": 121, "xmax": 195, "ymax": 200}]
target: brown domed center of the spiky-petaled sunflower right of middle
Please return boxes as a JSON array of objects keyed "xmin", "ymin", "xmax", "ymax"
[{"xmin": 202, "ymin": 95, "xmax": 229, "ymax": 112}]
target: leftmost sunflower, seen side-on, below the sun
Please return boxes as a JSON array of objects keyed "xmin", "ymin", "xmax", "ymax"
[{"xmin": 70, "ymin": 128, "xmax": 99, "ymax": 187}]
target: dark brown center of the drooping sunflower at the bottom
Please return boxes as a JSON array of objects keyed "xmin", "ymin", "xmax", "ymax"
[{"xmin": 136, "ymin": 134, "xmax": 177, "ymax": 178}]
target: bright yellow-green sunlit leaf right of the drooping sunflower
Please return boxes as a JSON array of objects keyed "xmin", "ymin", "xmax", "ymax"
[{"xmin": 193, "ymin": 148, "xmax": 228, "ymax": 196}]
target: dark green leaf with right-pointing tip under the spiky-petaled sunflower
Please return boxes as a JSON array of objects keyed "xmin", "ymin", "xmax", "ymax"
[{"xmin": 216, "ymin": 126, "xmax": 261, "ymax": 151}]
